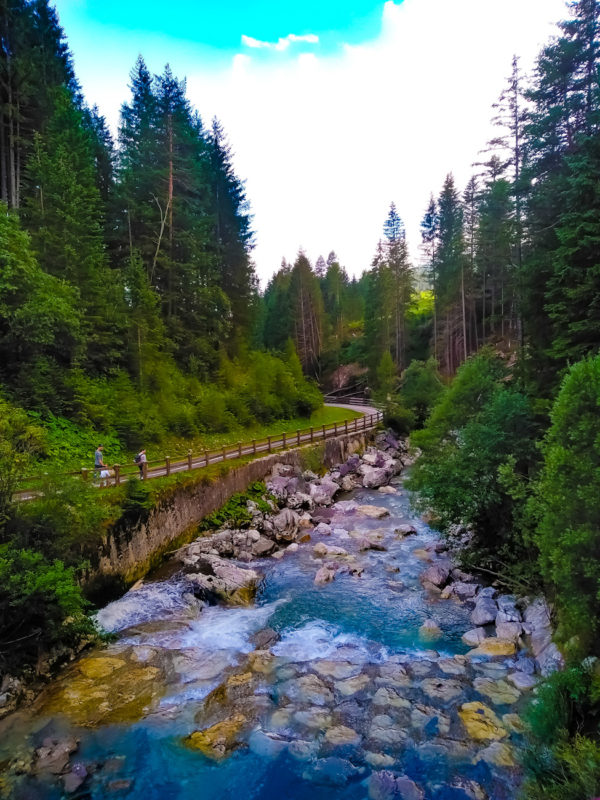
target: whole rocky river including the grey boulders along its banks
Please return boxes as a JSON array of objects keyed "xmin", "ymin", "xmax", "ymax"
[{"xmin": 0, "ymin": 434, "xmax": 560, "ymax": 800}]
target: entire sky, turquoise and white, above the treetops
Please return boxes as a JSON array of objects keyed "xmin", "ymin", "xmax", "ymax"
[{"xmin": 55, "ymin": 0, "xmax": 566, "ymax": 286}]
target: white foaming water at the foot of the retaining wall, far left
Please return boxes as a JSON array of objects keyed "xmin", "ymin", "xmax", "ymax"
[{"xmin": 96, "ymin": 581, "xmax": 202, "ymax": 633}]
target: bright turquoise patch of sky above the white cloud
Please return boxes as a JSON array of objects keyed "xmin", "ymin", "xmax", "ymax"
[{"xmin": 56, "ymin": 0, "xmax": 390, "ymax": 67}]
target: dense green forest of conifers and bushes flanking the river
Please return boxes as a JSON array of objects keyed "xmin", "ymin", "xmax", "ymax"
[{"xmin": 0, "ymin": 0, "xmax": 600, "ymax": 800}]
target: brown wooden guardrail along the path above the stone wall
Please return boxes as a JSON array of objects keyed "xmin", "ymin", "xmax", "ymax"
[{"xmin": 15, "ymin": 401, "xmax": 383, "ymax": 500}]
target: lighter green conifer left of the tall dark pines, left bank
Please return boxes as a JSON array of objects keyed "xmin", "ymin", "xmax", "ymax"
[{"xmin": 23, "ymin": 90, "xmax": 125, "ymax": 373}]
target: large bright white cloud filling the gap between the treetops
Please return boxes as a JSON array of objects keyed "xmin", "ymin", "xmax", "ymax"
[{"xmin": 188, "ymin": 0, "xmax": 566, "ymax": 281}]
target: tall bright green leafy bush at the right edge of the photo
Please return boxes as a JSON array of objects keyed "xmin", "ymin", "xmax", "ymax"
[{"xmin": 530, "ymin": 356, "xmax": 600, "ymax": 653}]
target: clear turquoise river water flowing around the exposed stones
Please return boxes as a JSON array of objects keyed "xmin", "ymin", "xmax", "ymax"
[{"xmin": 0, "ymin": 484, "xmax": 518, "ymax": 800}]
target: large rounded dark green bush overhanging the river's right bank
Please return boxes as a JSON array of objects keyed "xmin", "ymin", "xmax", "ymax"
[{"xmin": 409, "ymin": 353, "xmax": 535, "ymax": 566}]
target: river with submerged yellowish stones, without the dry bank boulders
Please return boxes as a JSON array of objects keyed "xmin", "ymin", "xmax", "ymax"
[{"xmin": 0, "ymin": 477, "xmax": 525, "ymax": 800}]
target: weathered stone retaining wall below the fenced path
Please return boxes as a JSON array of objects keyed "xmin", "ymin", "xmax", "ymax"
[{"xmin": 89, "ymin": 430, "xmax": 374, "ymax": 584}]
